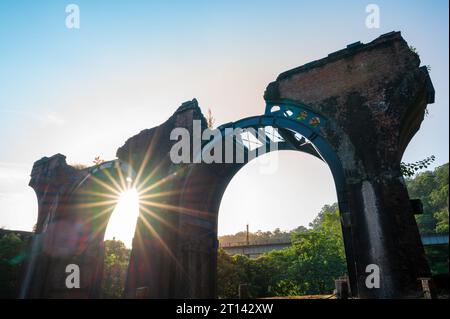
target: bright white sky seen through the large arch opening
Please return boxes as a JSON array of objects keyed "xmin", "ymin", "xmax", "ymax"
[{"xmin": 219, "ymin": 151, "xmax": 337, "ymax": 234}]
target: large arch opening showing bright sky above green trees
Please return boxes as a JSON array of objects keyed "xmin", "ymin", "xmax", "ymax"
[{"xmin": 217, "ymin": 150, "xmax": 347, "ymax": 298}]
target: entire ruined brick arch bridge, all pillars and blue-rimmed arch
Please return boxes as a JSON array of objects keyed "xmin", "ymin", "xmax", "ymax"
[{"xmin": 23, "ymin": 32, "xmax": 434, "ymax": 298}]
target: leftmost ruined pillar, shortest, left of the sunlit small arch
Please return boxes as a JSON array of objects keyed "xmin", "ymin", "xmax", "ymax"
[{"xmin": 20, "ymin": 154, "xmax": 133, "ymax": 298}]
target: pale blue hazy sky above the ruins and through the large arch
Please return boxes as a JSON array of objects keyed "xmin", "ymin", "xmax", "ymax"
[{"xmin": 0, "ymin": 0, "xmax": 449, "ymax": 248}]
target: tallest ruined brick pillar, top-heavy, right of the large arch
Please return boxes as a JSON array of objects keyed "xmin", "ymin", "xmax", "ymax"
[{"xmin": 265, "ymin": 32, "xmax": 434, "ymax": 298}]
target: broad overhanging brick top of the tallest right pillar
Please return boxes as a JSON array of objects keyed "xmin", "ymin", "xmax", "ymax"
[{"xmin": 265, "ymin": 32, "xmax": 434, "ymax": 170}]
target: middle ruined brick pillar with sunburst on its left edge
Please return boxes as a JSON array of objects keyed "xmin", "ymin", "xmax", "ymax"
[{"xmin": 117, "ymin": 99, "xmax": 207, "ymax": 298}]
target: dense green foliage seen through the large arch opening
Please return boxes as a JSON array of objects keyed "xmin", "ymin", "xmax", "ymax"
[{"xmin": 217, "ymin": 205, "xmax": 346, "ymax": 298}]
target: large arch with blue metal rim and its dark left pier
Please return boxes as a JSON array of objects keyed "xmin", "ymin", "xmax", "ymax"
[{"xmin": 177, "ymin": 105, "xmax": 357, "ymax": 298}]
